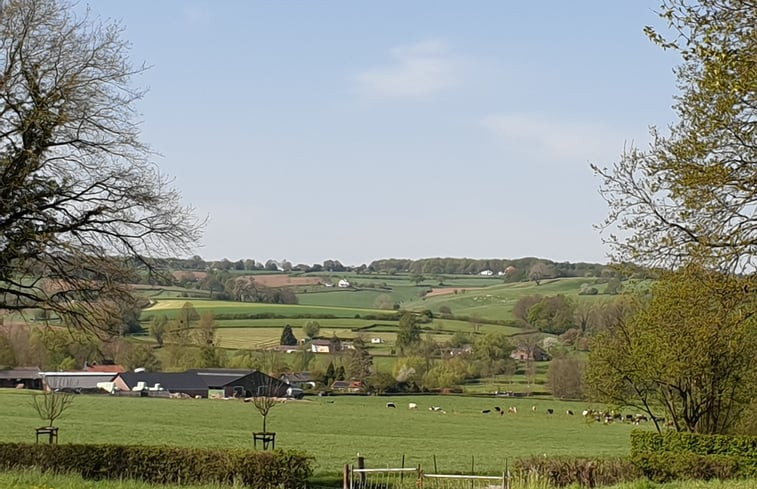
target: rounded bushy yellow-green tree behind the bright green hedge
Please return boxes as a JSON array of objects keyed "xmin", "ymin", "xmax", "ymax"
[{"xmin": 587, "ymin": 265, "xmax": 757, "ymax": 433}]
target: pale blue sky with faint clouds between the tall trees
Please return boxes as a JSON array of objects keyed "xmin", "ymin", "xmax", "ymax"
[{"xmin": 87, "ymin": 0, "xmax": 678, "ymax": 265}]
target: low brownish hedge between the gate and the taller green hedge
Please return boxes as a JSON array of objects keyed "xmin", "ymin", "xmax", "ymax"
[{"xmin": 514, "ymin": 457, "xmax": 642, "ymax": 487}]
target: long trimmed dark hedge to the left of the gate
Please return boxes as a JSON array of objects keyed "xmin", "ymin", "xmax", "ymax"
[{"xmin": 0, "ymin": 443, "xmax": 313, "ymax": 489}]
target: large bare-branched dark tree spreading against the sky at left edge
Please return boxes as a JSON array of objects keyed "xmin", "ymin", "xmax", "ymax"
[{"xmin": 0, "ymin": 0, "xmax": 201, "ymax": 333}]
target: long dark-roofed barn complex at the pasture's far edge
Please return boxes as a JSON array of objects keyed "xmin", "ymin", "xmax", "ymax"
[{"xmin": 114, "ymin": 369, "xmax": 289, "ymax": 397}]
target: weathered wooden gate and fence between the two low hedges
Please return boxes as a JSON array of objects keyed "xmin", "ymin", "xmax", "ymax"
[{"xmin": 342, "ymin": 465, "xmax": 510, "ymax": 489}]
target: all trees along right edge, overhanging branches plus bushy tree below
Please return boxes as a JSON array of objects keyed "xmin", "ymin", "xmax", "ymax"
[{"xmin": 587, "ymin": 0, "xmax": 757, "ymax": 434}]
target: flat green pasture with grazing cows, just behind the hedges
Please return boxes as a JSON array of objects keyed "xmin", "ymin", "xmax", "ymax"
[{"xmin": 0, "ymin": 389, "xmax": 652, "ymax": 477}]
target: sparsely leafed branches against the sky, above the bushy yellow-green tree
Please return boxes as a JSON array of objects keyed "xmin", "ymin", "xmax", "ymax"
[{"xmin": 593, "ymin": 0, "xmax": 757, "ymax": 271}]
